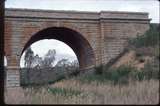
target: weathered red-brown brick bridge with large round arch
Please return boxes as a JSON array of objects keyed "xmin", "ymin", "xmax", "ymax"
[{"xmin": 5, "ymin": 9, "xmax": 150, "ymax": 86}]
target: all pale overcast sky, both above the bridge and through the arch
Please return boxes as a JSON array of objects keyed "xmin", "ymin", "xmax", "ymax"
[{"xmin": 5, "ymin": 0, "xmax": 160, "ymax": 67}]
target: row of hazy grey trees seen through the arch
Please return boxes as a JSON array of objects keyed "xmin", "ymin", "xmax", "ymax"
[{"xmin": 24, "ymin": 47, "xmax": 78, "ymax": 68}]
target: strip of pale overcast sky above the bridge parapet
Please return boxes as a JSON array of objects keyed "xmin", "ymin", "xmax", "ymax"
[{"xmin": 5, "ymin": 0, "xmax": 159, "ymax": 23}]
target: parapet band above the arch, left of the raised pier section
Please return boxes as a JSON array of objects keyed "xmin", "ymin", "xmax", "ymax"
[{"xmin": 5, "ymin": 9, "xmax": 99, "ymax": 19}]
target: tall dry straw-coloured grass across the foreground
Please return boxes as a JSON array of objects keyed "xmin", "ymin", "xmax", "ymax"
[{"xmin": 5, "ymin": 78, "xmax": 159, "ymax": 104}]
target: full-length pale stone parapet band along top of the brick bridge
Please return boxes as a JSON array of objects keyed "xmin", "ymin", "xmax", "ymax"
[{"xmin": 5, "ymin": 8, "xmax": 148, "ymax": 20}]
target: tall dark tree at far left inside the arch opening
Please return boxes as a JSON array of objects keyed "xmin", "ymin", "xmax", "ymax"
[{"xmin": 24, "ymin": 47, "xmax": 34, "ymax": 68}]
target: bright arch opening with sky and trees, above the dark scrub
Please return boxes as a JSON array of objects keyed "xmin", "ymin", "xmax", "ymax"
[{"xmin": 20, "ymin": 39, "xmax": 79, "ymax": 68}]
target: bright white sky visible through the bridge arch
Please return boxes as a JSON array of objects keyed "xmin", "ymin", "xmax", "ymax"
[{"xmin": 20, "ymin": 39, "xmax": 77, "ymax": 67}]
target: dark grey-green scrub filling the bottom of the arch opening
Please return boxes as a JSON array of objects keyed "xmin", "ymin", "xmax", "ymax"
[{"xmin": 20, "ymin": 67, "xmax": 79, "ymax": 86}]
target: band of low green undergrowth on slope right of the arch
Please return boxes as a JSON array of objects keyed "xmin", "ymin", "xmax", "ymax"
[{"xmin": 77, "ymin": 62, "xmax": 160, "ymax": 85}]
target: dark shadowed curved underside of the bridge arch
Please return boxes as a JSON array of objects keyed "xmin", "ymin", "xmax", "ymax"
[{"xmin": 21, "ymin": 27, "xmax": 95, "ymax": 70}]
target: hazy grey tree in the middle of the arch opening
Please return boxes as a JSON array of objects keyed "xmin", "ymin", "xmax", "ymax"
[{"xmin": 42, "ymin": 49, "xmax": 56, "ymax": 67}]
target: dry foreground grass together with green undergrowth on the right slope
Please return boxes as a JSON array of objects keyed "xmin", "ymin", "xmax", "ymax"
[{"xmin": 5, "ymin": 62, "xmax": 159, "ymax": 104}]
